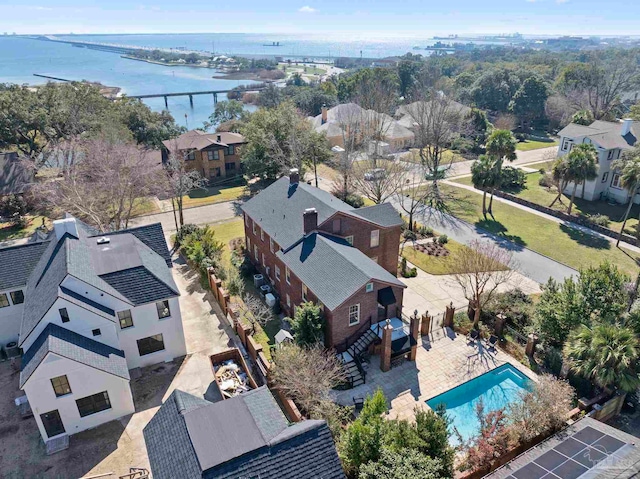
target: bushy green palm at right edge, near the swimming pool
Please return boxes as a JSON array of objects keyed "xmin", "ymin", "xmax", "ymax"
[{"xmin": 563, "ymin": 324, "xmax": 640, "ymax": 392}]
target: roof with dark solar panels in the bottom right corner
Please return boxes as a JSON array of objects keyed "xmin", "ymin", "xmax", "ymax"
[{"xmin": 486, "ymin": 417, "xmax": 640, "ymax": 479}]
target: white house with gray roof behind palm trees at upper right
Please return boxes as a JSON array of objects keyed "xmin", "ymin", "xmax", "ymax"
[{"xmin": 558, "ymin": 120, "xmax": 640, "ymax": 203}]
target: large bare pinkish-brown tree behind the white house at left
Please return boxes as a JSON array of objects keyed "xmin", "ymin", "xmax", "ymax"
[{"xmin": 37, "ymin": 135, "xmax": 162, "ymax": 231}]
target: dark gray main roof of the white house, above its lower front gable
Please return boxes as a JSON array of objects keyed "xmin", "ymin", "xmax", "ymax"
[{"xmin": 20, "ymin": 220, "xmax": 178, "ymax": 344}]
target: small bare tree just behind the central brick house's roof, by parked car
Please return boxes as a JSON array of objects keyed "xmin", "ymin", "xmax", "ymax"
[{"xmin": 353, "ymin": 160, "xmax": 405, "ymax": 205}]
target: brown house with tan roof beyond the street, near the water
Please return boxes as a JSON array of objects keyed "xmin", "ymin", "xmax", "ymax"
[{"xmin": 162, "ymin": 130, "xmax": 246, "ymax": 182}]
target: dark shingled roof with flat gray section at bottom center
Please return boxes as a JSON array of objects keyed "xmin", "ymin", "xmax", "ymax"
[{"xmin": 143, "ymin": 386, "xmax": 344, "ymax": 479}]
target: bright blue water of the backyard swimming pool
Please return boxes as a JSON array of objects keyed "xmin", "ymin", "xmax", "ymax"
[{"xmin": 427, "ymin": 364, "xmax": 531, "ymax": 445}]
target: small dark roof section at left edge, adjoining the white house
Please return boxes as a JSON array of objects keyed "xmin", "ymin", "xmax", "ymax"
[{"xmin": 0, "ymin": 241, "xmax": 49, "ymax": 291}]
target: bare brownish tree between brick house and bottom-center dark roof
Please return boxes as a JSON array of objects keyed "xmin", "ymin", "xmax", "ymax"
[{"xmin": 269, "ymin": 344, "xmax": 345, "ymax": 416}]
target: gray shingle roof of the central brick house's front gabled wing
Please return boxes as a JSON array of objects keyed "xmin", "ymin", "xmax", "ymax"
[{"xmin": 277, "ymin": 233, "xmax": 404, "ymax": 310}]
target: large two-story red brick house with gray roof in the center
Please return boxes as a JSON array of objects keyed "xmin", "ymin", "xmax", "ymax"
[{"xmin": 242, "ymin": 170, "xmax": 405, "ymax": 351}]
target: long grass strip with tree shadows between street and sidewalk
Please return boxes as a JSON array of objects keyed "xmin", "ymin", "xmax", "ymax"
[{"xmin": 441, "ymin": 185, "xmax": 639, "ymax": 276}]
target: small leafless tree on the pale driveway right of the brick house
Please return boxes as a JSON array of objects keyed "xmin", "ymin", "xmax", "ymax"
[{"xmin": 449, "ymin": 240, "xmax": 515, "ymax": 328}]
